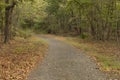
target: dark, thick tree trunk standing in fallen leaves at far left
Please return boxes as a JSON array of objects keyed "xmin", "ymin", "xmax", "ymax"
[{"xmin": 4, "ymin": 0, "xmax": 33, "ymax": 43}]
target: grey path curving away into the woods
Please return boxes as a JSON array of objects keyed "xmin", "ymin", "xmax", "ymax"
[{"xmin": 28, "ymin": 38, "xmax": 107, "ymax": 80}]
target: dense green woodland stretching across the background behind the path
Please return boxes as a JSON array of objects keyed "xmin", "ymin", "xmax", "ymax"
[{"xmin": 0, "ymin": 0, "xmax": 120, "ymax": 43}]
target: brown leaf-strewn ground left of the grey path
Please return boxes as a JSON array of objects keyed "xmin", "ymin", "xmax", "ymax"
[{"xmin": 0, "ymin": 37, "xmax": 47, "ymax": 80}]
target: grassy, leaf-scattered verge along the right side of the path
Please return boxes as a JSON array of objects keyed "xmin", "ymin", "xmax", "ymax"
[{"xmin": 59, "ymin": 37, "xmax": 120, "ymax": 74}]
